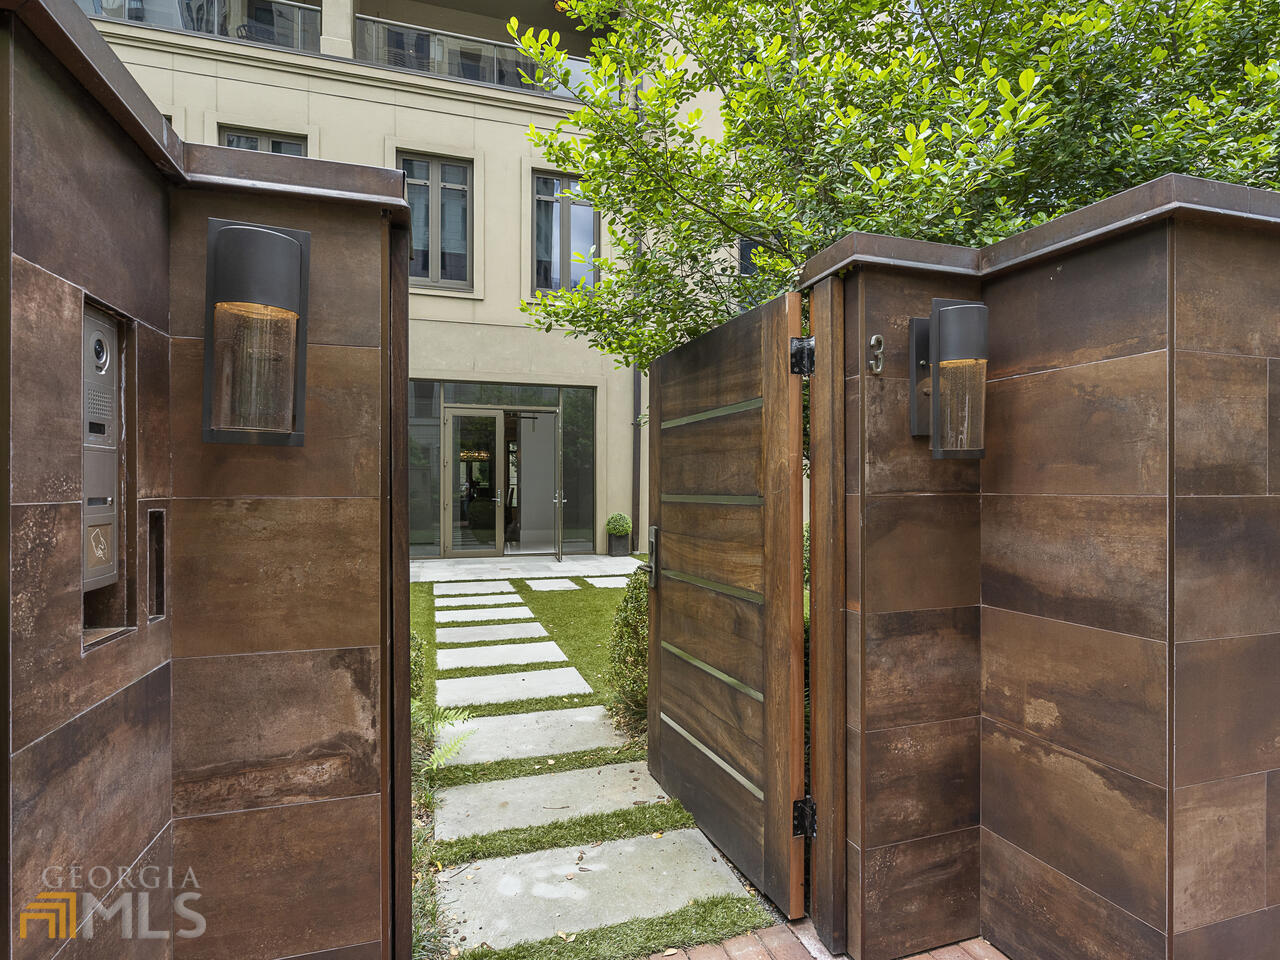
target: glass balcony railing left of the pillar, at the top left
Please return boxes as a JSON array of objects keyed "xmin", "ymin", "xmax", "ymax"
[{"xmin": 76, "ymin": 0, "xmax": 320, "ymax": 54}]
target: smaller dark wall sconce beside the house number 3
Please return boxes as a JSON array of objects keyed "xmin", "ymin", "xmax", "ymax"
[{"xmin": 910, "ymin": 300, "xmax": 987, "ymax": 460}]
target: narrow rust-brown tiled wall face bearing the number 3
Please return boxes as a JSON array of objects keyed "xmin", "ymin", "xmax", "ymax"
[{"xmin": 845, "ymin": 266, "xmax": 982, "ymax": 960}]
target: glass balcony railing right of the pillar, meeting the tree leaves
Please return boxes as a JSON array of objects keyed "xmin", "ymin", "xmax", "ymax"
[{"xmin": 355, "ymin": 15, "xmax": 586, "ymax": 97}]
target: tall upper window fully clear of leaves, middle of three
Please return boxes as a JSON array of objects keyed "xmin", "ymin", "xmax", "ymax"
[{"xmin": 399, "ymin": 156, "xmax": 474, "ymax": 289}]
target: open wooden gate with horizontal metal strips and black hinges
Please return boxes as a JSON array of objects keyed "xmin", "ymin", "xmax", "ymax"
[{"xmin": 649, "ymin": 293, "xmax": 804, "ymax": 918}]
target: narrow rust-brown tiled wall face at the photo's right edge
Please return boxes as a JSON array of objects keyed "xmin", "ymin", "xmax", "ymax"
[{"xmin": 1171, "ymin": 220, "xmax": 1280, "ymax": 960}]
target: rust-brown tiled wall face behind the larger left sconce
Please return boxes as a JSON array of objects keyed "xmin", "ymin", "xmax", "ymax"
[{"xmin": 170, "ymin": 184, "xmax": 390, "ymax": 960}]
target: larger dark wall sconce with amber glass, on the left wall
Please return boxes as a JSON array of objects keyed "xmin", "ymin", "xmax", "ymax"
[{"xmin": 204, "ymin": 219, "xmax": 311, "ymax": 447}]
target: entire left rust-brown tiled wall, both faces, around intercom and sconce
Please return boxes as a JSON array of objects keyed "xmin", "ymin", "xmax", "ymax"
[{"xmin": 0, "ymin": 4, "xmax": 404, "ymax": 960}]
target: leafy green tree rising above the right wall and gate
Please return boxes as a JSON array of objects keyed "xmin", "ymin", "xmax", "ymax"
[{"xmin": 511, "ymin": 0, "xmax": 1280, "ymax": 366}]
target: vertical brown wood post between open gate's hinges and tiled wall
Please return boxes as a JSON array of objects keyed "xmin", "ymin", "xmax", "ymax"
[{"xmin": 809, "ymin": 278, "xmax": 849, "ymax": 954}]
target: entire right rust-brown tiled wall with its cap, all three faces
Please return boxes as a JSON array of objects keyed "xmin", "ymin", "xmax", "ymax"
[{"xmin": 810, "ymin": 178, "xmax": 1280, "ymax": 960}]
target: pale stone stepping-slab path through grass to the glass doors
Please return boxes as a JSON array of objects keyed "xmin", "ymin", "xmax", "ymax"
[{"xmin": 433, "ymin": 570, "xmax": 749, "ymax": 948}]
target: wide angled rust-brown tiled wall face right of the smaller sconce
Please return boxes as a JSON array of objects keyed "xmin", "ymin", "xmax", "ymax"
[{"xmin": 982, "ymin": 223, "xmax": 1170, "ymax": 960}]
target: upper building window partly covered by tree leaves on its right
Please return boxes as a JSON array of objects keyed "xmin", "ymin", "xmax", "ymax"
[{"xmin": 534, "ymin": 173, "xmax": 600, "ymax": 291}]
